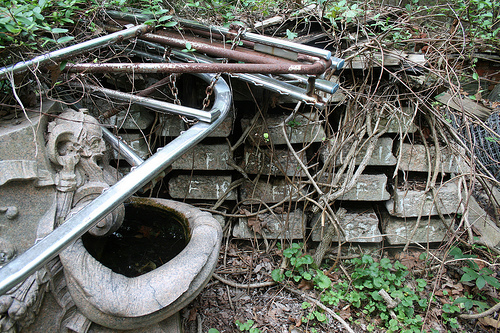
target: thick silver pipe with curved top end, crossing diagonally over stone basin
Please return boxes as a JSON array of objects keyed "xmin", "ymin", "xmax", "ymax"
[{"xmin": 0, "ymin": 74, "xmax": 231, "ymax": 295}]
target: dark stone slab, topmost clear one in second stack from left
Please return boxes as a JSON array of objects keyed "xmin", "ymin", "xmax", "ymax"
[{"xmin": 241, "ymin": 113, "xmax": 325, "ymax": 145}]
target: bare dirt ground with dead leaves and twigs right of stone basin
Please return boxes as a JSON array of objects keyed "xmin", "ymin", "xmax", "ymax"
[{"xmin": 181, "ymin": 235, "xmax": 500, "ymax": 333}]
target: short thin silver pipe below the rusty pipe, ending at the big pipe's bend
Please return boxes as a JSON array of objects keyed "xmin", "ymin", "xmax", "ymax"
[{"xmin": 68, "ymin": 81, "xmax": 220, "ymax": 123}]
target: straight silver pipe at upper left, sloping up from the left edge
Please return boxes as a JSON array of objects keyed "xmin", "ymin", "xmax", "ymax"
[{"xmin": 0, "ymin": 24, "xmax": 152, "ymax": 80}]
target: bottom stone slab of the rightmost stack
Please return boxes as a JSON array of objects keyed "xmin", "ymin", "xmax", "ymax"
[{"xmin": 382, "ymin": 214, "xmax": 453, "ymax": 245}]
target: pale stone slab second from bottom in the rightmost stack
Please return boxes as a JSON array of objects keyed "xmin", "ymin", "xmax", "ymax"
[{"xmin": 386, "ymin": 183, "xmax": 462, "ymax": 217}]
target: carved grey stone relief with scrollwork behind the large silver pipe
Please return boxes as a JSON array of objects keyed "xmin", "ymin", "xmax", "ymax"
[{"xmin": 0, "ymin": 110, "xmax": 125, "ymax": 333}]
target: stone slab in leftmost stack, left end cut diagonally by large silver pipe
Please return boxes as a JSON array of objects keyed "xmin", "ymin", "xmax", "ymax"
[{"xmin": 172, "ymin": 143, "xmax": 233, "ymax": 170}]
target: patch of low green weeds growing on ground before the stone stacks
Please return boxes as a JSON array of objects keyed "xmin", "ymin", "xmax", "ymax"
[{"xmin": 272, "ymin": 243, "xmax": 430, "ymax": 332}]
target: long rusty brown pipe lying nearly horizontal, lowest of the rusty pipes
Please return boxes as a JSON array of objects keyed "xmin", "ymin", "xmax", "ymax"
[{"xmin": 66, "ymin": 59, "xmax": 329, "ymax": 75}]
